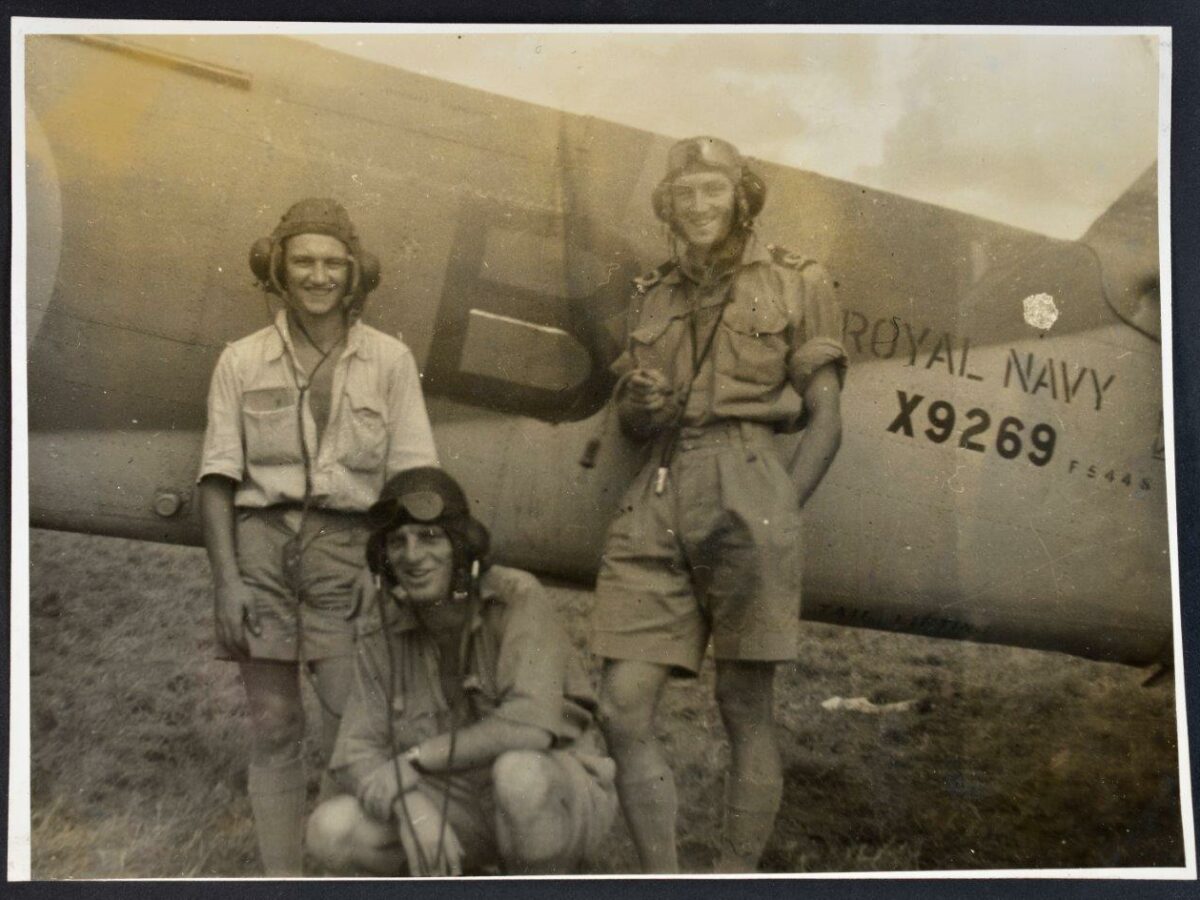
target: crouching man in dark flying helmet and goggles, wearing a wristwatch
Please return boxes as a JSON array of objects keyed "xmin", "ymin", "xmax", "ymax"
[{"xmin": 307, "ymin": 468, "xmax": 616, "ymax": 875}]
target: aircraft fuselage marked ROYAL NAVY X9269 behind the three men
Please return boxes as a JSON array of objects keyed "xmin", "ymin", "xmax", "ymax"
[{"xmin": 26, "ymin": 36, "xmax": 1171, "ymax": 664}]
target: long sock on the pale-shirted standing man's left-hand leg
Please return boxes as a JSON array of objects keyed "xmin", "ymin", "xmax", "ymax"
[{"xmin": 247, "ymin": 760, "xmax": 305, "ymax": 875}]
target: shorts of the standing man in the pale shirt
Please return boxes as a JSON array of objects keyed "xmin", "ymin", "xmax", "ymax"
[{"xmin": 230, "ymin": 508, "xmax": 368, "ymax": 661}]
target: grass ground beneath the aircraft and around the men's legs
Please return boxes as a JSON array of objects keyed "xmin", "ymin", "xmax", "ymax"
[{"xmin": 23, "ymin": 532, "xmax": 1183, "ymax": 878}]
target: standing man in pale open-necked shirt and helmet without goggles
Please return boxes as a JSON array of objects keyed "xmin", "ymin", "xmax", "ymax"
[{"xmin": 199, "ymin": 198, "xmax": 437, "ymax": 875}]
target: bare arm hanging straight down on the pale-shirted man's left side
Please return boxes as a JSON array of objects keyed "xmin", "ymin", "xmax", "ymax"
[{"xmin": 199, "ymin": 475, "xmax": 260, "ymax": 655}]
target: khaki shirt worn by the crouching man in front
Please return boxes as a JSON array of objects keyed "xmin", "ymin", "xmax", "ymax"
[{"xmin": 329, "ymin": 566, "xmax": 596, "ymax": 788}]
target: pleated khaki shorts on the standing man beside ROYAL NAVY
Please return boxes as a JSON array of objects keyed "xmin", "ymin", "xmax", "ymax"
[{"xmin": 592, "ymin": 422, "xmax": 803, "ymax": 676}]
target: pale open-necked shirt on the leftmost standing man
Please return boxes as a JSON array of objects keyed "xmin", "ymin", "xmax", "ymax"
[{"xmin": 199, "ymin": 310, "xmax": 438, "ymax": 511}]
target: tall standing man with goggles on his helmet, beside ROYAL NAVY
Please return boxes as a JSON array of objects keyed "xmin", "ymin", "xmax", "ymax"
[{"xmin": 592, "ymin": 137, "xmax": 846, "ymax": 872}]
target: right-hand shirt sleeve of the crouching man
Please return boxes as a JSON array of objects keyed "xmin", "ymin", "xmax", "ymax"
[{"xmin": 493, "ymin": 576, "xmax": 581, "ymax": 745}]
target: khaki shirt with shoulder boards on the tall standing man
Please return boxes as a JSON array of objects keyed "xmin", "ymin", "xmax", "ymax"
[{"xmin": 612, "ymin": 234, "xmax": 847, "ymax": 431}]
